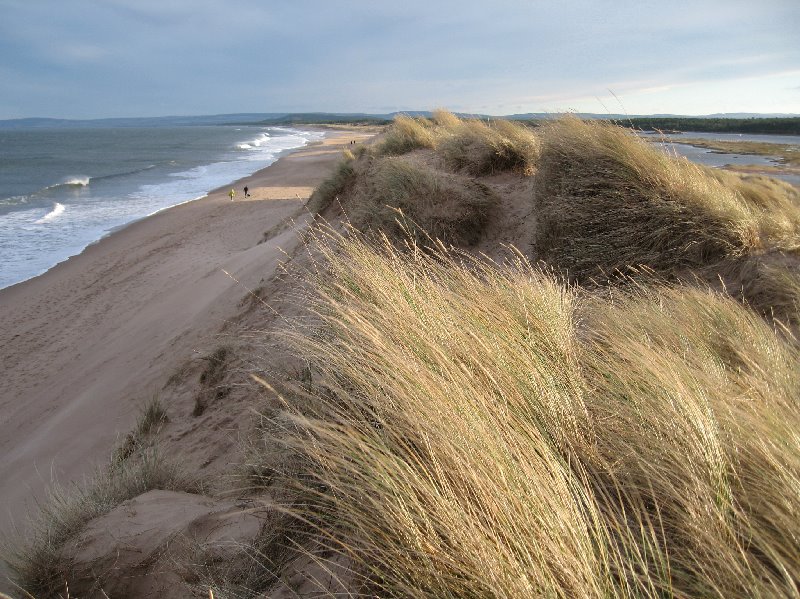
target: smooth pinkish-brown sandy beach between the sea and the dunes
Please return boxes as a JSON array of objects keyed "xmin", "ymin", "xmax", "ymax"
[{"xmin": 0, "ymin": 130, "xmax": 370, "ymax": 532}]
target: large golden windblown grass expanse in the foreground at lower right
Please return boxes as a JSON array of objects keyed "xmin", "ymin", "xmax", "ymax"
[{"xmin": 268, "ymin": 232, "xmax": 800, "ymax": 598}]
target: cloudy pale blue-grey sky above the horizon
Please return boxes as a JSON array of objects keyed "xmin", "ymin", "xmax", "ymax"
[{"xmin": 0, "ymin": 0, "xmax": 800, "ymax": 119}]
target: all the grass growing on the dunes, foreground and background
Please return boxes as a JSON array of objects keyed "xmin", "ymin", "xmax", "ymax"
[{"xmin": 14, "ymin": 111, "xmax": 800, "ymax": 599}]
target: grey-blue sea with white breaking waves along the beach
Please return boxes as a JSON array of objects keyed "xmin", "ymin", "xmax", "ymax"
[{"xmin": 0, "ymin": 121, "xmax": 325, "ymax": 289}]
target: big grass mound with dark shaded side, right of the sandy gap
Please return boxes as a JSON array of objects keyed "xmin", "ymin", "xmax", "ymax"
[{"xmin": 535, "ymin": 118, "xmax": 800, "ymax": 280}]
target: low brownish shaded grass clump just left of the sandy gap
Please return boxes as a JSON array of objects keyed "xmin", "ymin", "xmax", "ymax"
[{"xmin": 352, "ymin": 158, "xmax": 494, "ymax": 245}]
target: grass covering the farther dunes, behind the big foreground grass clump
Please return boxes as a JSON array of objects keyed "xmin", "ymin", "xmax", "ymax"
[{"xmin": 310, "ymin": 110, "xmax": 800, "ymax": 322}]
